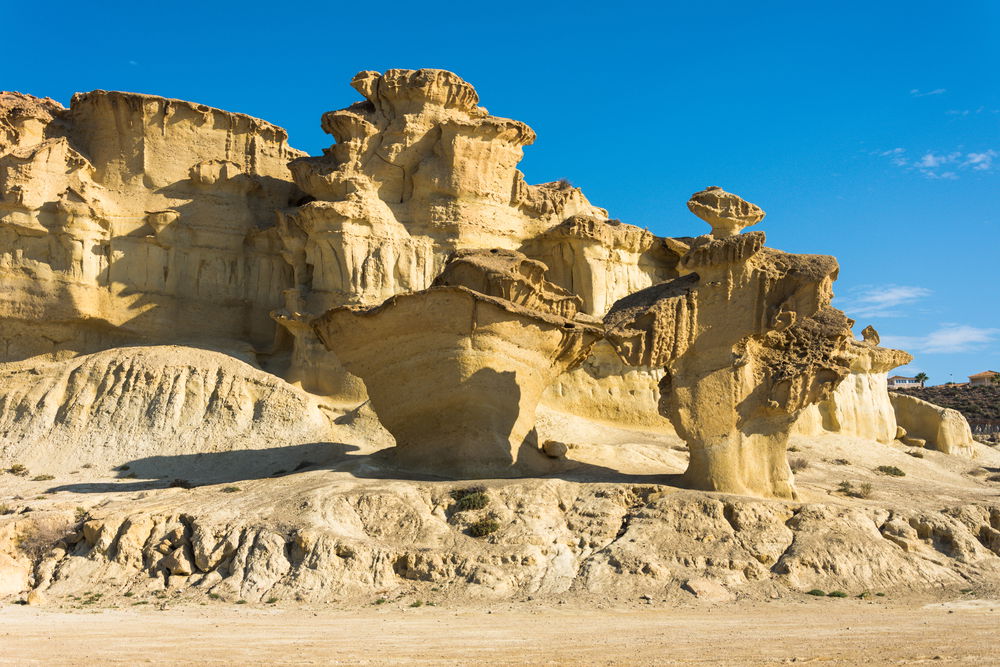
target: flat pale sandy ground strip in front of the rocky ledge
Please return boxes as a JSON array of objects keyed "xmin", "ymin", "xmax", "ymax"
[{"xmin": 0, "ymin": 599, "xmax": 1000, "ymax": 665}]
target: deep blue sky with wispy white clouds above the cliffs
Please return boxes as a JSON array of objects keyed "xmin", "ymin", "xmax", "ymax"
[{"xmin": 9, "ymin": 0, "xmax": 1000, "ymax": 384}]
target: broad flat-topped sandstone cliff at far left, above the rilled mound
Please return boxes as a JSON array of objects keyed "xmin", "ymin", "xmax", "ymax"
[{"xmin": 0, "ymin": 91, "xmax": 301, "ymax": 359}]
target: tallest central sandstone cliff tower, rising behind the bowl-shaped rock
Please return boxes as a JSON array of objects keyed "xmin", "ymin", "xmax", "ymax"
[{"xmin": 266, "ymin": 69, "xmax": 676, "ymax": 414}]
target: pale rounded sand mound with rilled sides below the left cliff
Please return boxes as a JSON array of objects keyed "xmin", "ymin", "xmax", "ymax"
[{"xmin": 0, "ymin": 345, "xmax": 366, "ymax": 477}]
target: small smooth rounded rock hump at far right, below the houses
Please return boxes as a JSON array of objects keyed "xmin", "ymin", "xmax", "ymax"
[{"xmin": 889, "ymin": 392, "xmax": 975, "ymax": 458}]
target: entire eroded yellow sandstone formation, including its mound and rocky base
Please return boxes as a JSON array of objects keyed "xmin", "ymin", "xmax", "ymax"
[{"xmin": 0, "ymin": 70, "xmax": 1000, "ymax": 604}]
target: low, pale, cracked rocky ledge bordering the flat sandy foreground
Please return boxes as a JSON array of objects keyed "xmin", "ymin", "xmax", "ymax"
[{"xmin": 0, "ymin": 480, "xmax": 1000, "ymax": 604}]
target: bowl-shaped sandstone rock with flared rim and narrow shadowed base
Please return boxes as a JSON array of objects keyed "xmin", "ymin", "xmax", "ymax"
[{"xmin": 313, "ymin": 249, "xmax": 601, "ymax": 477}]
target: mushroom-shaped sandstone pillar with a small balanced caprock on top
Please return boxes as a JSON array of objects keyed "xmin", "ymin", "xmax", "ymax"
[{"xmin": 605, "ymin": 187, "xmax": 850, "ymax": 497}]
